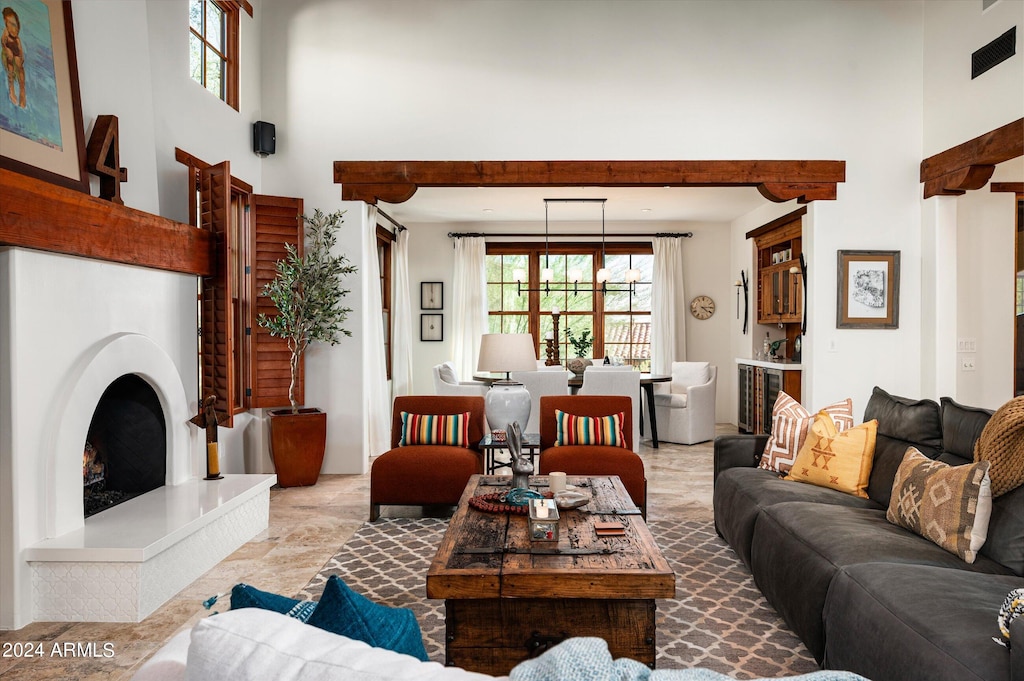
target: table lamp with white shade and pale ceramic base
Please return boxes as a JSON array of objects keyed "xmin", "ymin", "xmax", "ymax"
[{"xmin": 476, "ymin": 334, "xmax": 537, "ymax": 430}]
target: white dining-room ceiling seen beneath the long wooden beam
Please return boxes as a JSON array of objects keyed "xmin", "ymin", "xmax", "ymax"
[{"xmin": 380, "ymin": 186, "xmax": 768, "ymax": 225}]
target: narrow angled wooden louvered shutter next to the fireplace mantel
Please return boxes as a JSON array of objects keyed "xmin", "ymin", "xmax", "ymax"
[{"xmin": 200, "ymin": 161, "xmax": 238, "ymax": 427}]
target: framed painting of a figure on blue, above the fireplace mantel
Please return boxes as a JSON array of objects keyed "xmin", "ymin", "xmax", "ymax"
[{"xmin": 0, "ymin": 0, "xmax": 89, "ymax": 194}]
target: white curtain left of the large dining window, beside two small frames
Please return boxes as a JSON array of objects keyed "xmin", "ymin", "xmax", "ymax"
[{"xmin": 452, "ymin": 237, "xmax": 487, "ymax": 381}]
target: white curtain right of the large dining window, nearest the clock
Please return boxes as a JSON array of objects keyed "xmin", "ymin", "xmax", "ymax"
[{"xmin": 650, "ymin": 237, "xmax": 686, "ymax": 374}]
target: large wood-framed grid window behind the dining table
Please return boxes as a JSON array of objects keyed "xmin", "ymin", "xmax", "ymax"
[{"xmin": 486, "ymin": 244, "xmax": 654, "ymax": 371}]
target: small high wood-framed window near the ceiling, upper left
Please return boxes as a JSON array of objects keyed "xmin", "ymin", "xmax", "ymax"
[{"xmin": 188, "ymin": 0, "xmax": 253, "ymax": 110}]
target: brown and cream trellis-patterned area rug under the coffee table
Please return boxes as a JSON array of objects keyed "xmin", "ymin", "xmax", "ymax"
[{"xmin": 298, "ymin": 518, "xmax": 818, "ymax": 679}]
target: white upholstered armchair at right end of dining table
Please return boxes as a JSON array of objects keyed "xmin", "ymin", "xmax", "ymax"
[{"xmin": 654, "ymin": 361, "xmax": 718, "ymax": 444}]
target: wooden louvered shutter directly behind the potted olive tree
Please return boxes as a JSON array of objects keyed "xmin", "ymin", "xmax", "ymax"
[{"xmin": 248, "ymin": 194, "xmax": 305, "ymax": 408}]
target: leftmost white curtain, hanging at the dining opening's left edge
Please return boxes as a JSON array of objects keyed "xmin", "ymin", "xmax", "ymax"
[{"xmin": 361, "ymin": 205, "xmax": 391, "ymax": 457}]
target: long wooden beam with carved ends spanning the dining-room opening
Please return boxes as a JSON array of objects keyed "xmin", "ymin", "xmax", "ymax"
[{"xmin": 334, "ymin": 161, "xmax": 846, "ymax": 204}]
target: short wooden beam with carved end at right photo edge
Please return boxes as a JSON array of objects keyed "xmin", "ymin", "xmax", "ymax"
[{"xmin": 921, "ymin": 118, "xmax": 1024, "ymax": 199}]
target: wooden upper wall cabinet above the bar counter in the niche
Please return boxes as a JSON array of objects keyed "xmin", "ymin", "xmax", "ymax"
[{"xmin": 754, "ymin": 217, "xmax": 804, "ymax": 324}]
